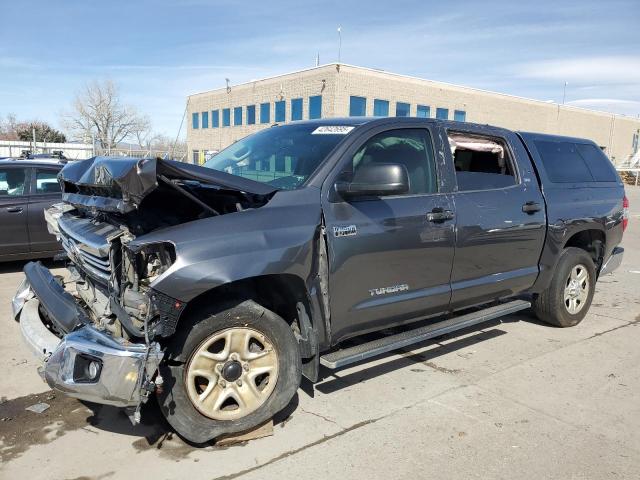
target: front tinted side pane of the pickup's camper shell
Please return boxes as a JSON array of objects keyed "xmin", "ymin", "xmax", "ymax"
[{"xmin": 535, "ymin": 140, "xmax": 593, "ymax": 183}]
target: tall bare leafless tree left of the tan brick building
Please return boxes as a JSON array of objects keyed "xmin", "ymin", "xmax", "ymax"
[{"xmin": 64, "ymin": 80, "xmax": 149, "ymax": 148}]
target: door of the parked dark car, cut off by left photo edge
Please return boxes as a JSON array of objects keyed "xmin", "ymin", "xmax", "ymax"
[{"xmin": 0, "ymin": 165, "xmax": 29, "ymax": 255}]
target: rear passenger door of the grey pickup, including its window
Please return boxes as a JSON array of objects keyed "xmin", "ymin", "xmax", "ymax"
[{"xmin": 447, "ymin": 125, "xmax": 546, "ymax": 309}]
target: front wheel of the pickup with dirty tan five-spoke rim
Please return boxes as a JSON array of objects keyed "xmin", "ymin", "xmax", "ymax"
[{"xmin": 157, "ymin": 300, "xmax": 302, "ymax": 444}]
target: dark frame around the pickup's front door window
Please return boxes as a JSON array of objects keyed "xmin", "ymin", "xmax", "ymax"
[{"xmin": 328, "ymin": 122, "xmax": 442, "ymax": 203}]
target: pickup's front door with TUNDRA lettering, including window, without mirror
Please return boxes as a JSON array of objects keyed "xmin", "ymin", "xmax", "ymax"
[{"xmin": 323, "ymin": 128, "xmax": 455, "ymax": 343}]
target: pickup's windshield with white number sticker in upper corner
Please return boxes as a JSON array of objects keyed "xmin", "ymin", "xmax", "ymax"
[{"xmin": 204, "ymin": 123, "xmax": 354, "ymax": 190}]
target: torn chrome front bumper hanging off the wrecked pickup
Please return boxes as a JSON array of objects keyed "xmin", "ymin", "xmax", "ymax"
[{"xmin": 12, "ymin": 267, "xmax": 163, "ymax": 407}]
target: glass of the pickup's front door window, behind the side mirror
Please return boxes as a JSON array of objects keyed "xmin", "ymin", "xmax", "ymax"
[{"xmin": 353, "ymin": 129, "xmax": 438, "ymax": 195}]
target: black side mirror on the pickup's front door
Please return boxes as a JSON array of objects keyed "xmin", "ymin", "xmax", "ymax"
[{"xmin": 336, "ymin": 163, "xmax": 409, "ymax": 198}]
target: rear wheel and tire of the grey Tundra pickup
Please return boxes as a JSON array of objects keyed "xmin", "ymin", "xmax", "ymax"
[{"xmin": 533, "ymin": 247, "xmax": 596, "ymax": 327}]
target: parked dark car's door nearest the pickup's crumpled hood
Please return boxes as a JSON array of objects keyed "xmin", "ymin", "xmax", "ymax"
[{"xmin": 27, "ymin": 167, "xmax": 62, "ymax": 253}]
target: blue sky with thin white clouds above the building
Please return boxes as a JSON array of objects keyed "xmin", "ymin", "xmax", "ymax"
[{"xmin": 0, "ymin": 0, "xmax": 640, "ymax": 136}]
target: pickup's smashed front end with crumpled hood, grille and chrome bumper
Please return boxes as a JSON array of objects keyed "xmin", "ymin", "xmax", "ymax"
[{"xmin": 12, "ymin": 157, "xmax": 273, "ymax": 420}]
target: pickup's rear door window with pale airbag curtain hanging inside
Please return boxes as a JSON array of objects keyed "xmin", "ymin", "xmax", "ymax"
[{"xmin": 449, "ymin": 132, "xmax": 516, "ymax": 191}]
